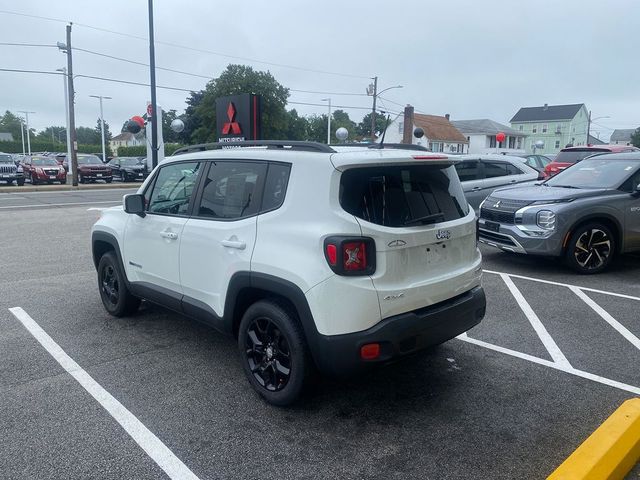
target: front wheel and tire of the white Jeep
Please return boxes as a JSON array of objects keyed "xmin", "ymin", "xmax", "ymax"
[{"xmin": 98, "ymin": 251, "xmax": 140, "ymax": 317}]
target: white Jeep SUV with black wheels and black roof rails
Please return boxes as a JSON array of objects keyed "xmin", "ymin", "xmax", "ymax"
[{"xmin": 91, "ymin": 141, "xmax": 485, "ymax": 405}]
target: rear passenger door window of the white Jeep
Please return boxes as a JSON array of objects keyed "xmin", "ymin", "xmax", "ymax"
[{"xmin": 195, "ymin": 162, "xmax": 267, "ymax": 220}]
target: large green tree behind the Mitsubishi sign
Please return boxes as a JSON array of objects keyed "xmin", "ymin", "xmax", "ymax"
[{"xmin": 185, "ymin": 65, "xmax": 289, "ymax": 143}]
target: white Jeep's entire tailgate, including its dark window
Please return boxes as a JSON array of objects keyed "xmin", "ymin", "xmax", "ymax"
[{"xmin": 341, "ymin": 162, "xmax": 480, "ymax": 318}]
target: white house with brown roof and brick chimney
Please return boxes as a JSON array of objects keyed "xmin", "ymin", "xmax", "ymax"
[{"xmin": 378, "ymin": 105, "xmax": 469, "ymax": 153}]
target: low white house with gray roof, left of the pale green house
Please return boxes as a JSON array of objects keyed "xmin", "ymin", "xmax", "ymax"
[{"xmin": 451, "ymin": 118, "xmax": 527, "ymax": 154}]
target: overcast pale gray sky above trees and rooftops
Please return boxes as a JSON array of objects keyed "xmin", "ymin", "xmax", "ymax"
[{"xmin": 0, "ymin": 0, "xmax": 640, "ymax": 139}]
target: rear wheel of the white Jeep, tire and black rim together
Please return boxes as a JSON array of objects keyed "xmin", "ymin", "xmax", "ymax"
[{"xmin": 238, "ymin": 300, "xmax": 312, "ymax": 406}]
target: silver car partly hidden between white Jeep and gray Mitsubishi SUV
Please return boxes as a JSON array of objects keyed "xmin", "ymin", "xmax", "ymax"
[{"xmin": 456, "ymin": 154, "xmax": 540, "ymax": 211}]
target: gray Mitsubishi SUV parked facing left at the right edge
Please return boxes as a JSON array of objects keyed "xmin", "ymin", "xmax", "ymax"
[{"xmin": 478, "ymin": 152, "xmax": 640, "ymax": 274}]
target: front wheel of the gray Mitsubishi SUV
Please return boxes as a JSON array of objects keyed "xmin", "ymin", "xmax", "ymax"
[{"xmin": 565, "ymin": 222, "xmax": 616, "ymax": 275}]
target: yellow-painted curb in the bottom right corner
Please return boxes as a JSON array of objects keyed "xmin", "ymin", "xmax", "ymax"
[{"xmin": 547, "ymin": 398, "xmax": 640, "ymax": 480}]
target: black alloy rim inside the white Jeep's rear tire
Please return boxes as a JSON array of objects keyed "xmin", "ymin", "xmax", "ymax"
[{"xmin": 245, "ymin": 317, "xmax": 291, "ymax": 392}]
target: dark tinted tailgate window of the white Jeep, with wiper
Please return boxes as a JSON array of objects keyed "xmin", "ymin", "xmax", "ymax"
[{"xmin": 340, "ymin": 165, "xmax": 469, "ymax": 227}]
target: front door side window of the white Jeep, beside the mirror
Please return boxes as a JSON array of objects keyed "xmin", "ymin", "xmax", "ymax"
[{"xmin": 145, "ymin": 162, "xmax": 200, "ymax": 215}]
